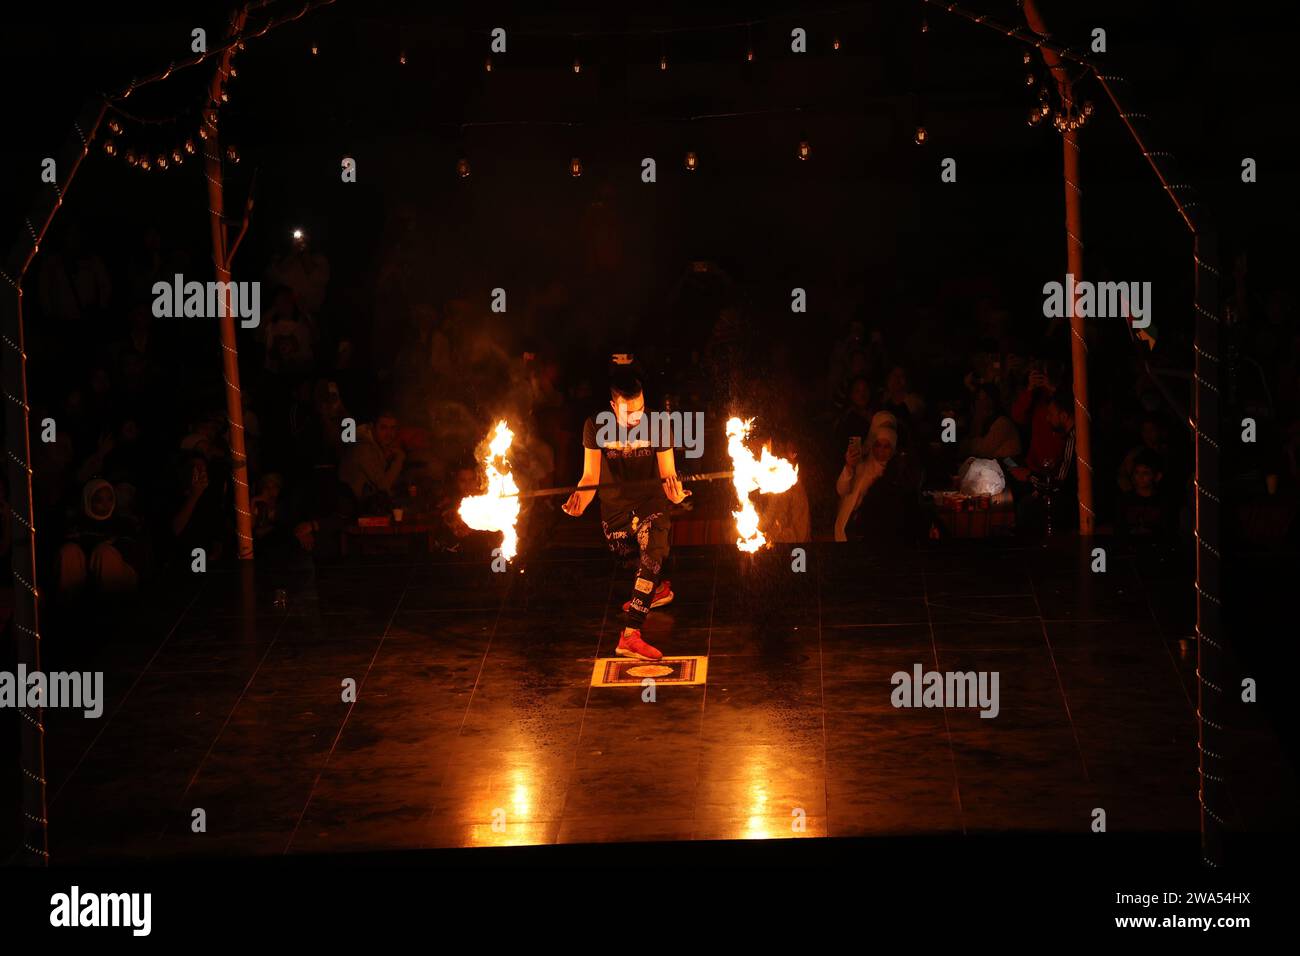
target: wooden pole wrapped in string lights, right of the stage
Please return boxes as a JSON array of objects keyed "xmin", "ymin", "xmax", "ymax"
[{"xmin": 1023, "ymin": 0, "xmax": 1095, "ymax": 536}]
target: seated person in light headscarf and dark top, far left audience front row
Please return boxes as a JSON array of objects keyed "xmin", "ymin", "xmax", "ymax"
[{"xmin": 59, "ymin": 479, "xmax": 139, "ymax": 594}]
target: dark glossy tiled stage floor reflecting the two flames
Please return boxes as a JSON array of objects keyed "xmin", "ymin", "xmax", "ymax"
[{"xmin": 40, "ymin": 545, "xmax": 1295, "ymax": 861}]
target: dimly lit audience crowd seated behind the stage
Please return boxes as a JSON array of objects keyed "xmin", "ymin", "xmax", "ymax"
[{"xmin": 0, "ymin": 201, "xmax": 1300, "ymax": 629}]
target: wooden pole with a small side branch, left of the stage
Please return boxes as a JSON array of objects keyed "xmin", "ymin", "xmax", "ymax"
[{"xmin": 203, "ymin": 7, "xmax": 252, "ymax": 561}]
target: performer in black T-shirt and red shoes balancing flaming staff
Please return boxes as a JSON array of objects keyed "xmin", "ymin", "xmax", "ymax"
[{"xmin": 564, "ymin": 368, "xmax": 690, "ymax": 661}]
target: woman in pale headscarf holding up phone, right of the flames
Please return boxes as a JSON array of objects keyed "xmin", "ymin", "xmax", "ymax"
[{"xmin": 835, "ymin": 412, "xmax": 918, "ymax": 544}]
